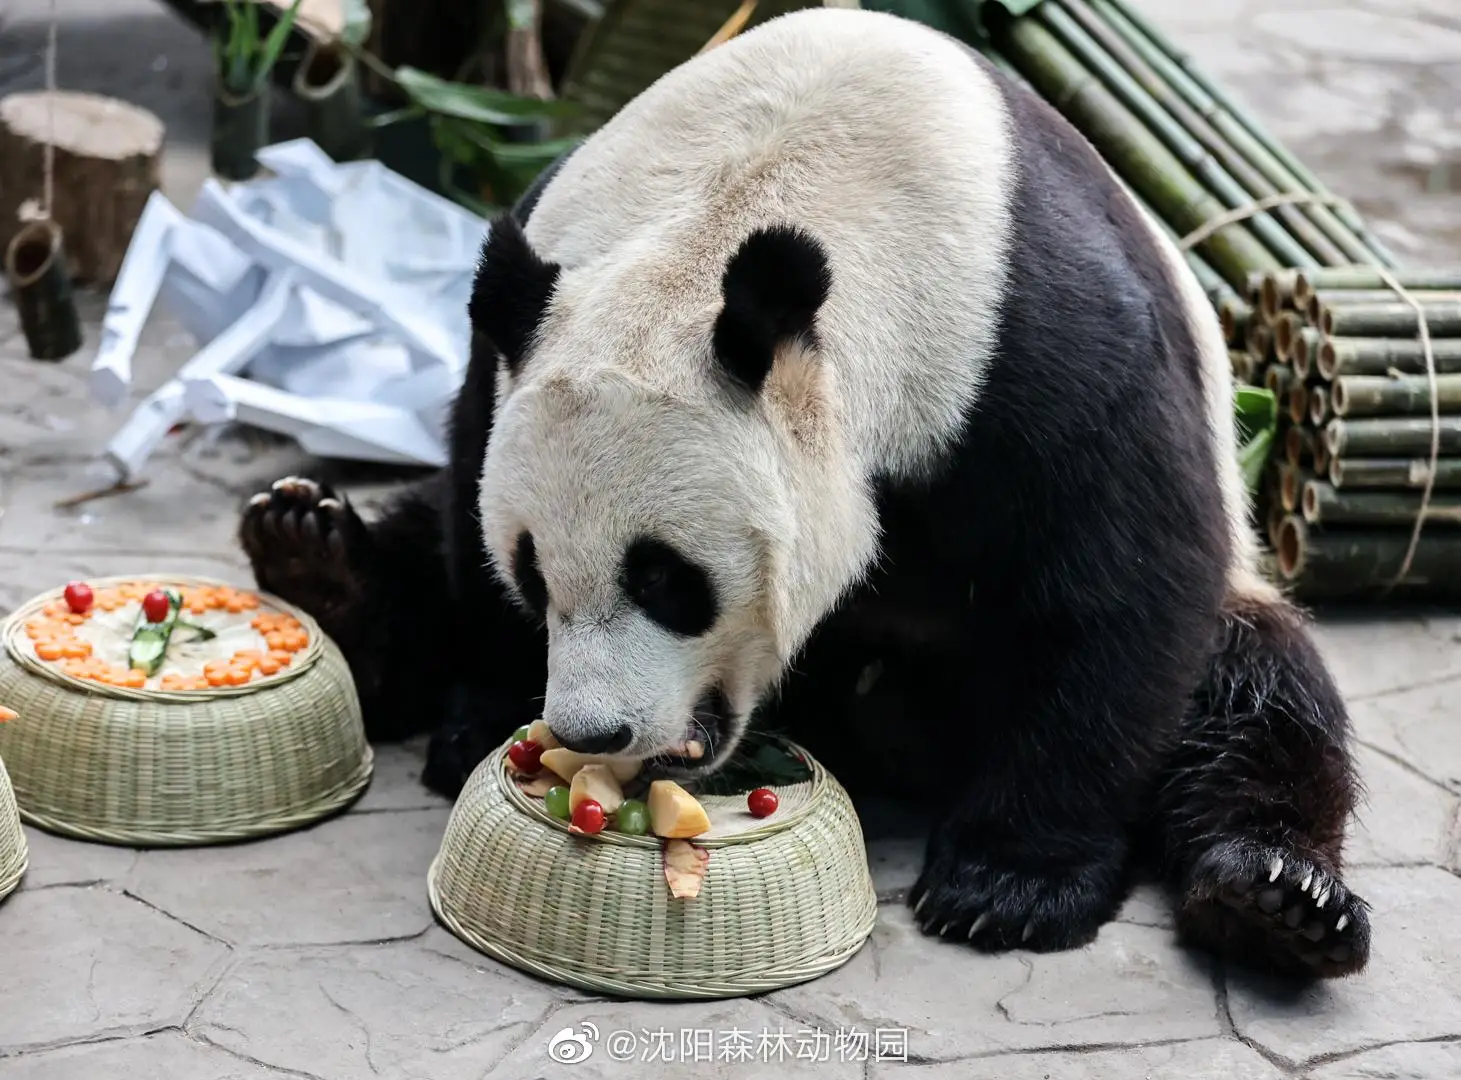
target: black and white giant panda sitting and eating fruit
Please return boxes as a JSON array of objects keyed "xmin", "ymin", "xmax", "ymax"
[{"xmin": 240, "ymin": 9, "xmax": 1369, "ymax": 976}]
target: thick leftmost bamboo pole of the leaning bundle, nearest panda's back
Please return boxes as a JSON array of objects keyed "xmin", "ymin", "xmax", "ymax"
[{"xmin": 991, "ymin": 19, "xmax": 1280, "ymax": 288}]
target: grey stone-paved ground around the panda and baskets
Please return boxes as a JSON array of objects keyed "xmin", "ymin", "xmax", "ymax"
[{"xmin": 0, "ymin": 0, "xmax": 1461, "ymax": 1080}]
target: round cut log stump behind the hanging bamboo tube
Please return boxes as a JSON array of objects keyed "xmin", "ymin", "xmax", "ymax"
[{"xmin": 0, "ymin": 91, "xmax": 164, "ymax": 285}]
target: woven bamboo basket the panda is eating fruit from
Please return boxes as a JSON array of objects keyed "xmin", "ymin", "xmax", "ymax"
[{"xmin": 428, "ymin": 744, "xmax": 878, "ymax": 998}]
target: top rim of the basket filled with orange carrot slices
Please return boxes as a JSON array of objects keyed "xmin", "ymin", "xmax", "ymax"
[{"xmin": 0, "ymin": 573, "xmax": 324, "ymax": 704}]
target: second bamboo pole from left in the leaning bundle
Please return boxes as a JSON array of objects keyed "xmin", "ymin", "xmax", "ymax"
[{"xmin": 1034, "ymin": 0, "xmax": 1344, "ymax": 267}]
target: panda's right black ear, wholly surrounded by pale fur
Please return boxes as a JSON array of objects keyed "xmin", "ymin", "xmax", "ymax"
[{"xmin": 712, "ymin": 225, "xmax": 831, "ymax": 393}]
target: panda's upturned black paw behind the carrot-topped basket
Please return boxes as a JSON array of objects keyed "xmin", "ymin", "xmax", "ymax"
[{"xmin": 238, "ymin": 476, "xmax": 370, "ymax": 640}]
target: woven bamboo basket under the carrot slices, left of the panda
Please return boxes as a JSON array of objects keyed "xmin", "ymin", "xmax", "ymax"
[{"xmin": 0, "ymin": 574, "xmax": 373, "ymax": 848}]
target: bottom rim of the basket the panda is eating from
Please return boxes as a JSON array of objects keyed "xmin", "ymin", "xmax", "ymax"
[{"xmin": 427, "ymin": 859, "xmax": 878, "ymax": 1001}]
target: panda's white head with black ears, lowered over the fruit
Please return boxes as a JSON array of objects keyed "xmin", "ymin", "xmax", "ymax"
[{"xmin": 470, "ymin": 218, "xmax": 866, "ymax": 776}]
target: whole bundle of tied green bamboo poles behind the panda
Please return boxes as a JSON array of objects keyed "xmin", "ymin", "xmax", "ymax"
[{"xmin": 982, "ymin": 0, "xmax": 1461, "ymax": 596}]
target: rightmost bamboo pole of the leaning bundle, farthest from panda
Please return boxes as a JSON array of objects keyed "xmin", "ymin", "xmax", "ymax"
[{"xmin": 1091, "ymin": 0, "xmax": 1395, "ymax": 266}]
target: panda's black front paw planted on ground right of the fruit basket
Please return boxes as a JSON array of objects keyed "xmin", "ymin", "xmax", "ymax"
[{"xmin": 909, "ymin": 834, "xmax": 1125, "ymax": 953}]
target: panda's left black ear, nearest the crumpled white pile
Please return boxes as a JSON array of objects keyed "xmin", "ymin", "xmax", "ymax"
[{"xmin": 468, "ymin": 213, "xmax": 560, "ymax": 374}]
